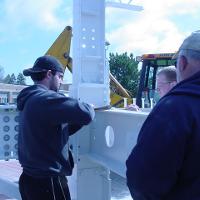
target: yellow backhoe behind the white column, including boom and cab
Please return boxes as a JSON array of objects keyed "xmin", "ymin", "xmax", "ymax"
[{"xmin": 46, "ymin": 26, "xmax": 177, "ymax": 107}]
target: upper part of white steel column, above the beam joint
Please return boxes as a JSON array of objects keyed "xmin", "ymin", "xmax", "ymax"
[{"xmin": 70, "ymin": 0, "xmax": 110, "ymax": 107}]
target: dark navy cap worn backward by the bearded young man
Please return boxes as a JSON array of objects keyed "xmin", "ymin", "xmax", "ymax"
[{"xmin": 23, "ymin": 55, "xmax": 64, "ymax": 76}]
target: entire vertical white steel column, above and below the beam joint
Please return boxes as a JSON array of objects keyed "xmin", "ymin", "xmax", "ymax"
[{"xmin": 70, "ymin": 0, "xmax": 111, "ymax": 200}]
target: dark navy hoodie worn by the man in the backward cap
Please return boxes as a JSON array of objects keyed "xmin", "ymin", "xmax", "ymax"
[{"xmin": 17, "ymin": 84, "xmax": 94, "ymax": 177}]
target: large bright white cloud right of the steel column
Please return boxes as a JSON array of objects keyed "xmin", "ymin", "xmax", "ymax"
[{"xmin": 107, "ymin": 0, "xmax": 200, "ymax": 54}]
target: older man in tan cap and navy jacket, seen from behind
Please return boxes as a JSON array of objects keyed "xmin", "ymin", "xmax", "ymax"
[{"xmin": 126, "ymin": 32, "xmax": 200, "ymax": 200}]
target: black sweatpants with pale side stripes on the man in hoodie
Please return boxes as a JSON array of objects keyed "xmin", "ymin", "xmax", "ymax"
[{"xmin": 19, "ymin": 172, "xmax": 71, "ymax": 200}]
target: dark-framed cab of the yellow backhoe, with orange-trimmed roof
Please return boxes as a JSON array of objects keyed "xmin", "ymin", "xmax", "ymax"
[{"xmin": 136, "ymin": 53, "xmax": 175, "ymax": 107}]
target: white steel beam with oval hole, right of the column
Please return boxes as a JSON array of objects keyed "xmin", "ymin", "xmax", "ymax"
[{"xmin": 88, "ymin": 110, "xmax": 148, "ymax": 177}]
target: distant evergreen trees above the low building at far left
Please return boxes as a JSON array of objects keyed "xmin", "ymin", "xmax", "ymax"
[{"xmin": 0, "ymin": 66, "xmax": 26, "ymax": 85}]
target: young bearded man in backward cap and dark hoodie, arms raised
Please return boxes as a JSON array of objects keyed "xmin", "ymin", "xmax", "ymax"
[{"xmin": 17, "ymin": 55, "xmax": 94, "ymax": 200}]
